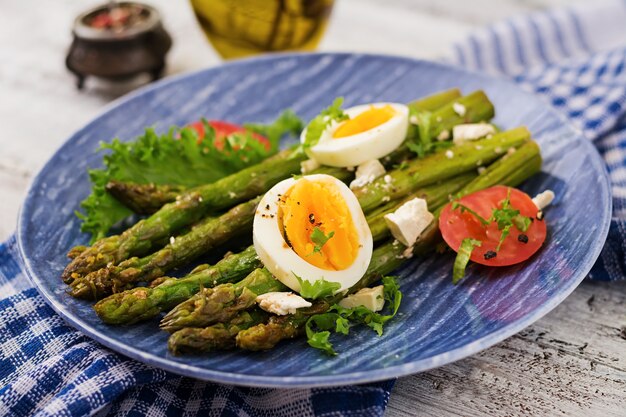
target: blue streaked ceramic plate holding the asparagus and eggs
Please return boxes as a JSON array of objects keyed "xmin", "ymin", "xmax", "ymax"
[{"xmin": 18, "ymin": 54, "xmax": 611, "ymax": 387}]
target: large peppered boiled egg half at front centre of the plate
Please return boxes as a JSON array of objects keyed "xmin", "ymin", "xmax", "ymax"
[{"xmin": 252, "ymin": 174, "xmax": 373, "ymax": 292}]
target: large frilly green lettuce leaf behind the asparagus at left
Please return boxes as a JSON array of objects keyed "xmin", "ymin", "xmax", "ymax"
[{"xmin": 76, "ymin": 113, "xmax": 297, "ymax": 242}]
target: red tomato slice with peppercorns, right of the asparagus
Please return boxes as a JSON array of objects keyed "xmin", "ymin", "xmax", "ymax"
[{"xmin": 439, "ymin": 185, "xmax": 546, "ymax": 266}]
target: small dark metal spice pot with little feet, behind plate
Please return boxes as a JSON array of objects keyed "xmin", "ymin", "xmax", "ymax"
[{"xmin": 65, "ymin": 2, "xmax": 172, "ymax": 89}]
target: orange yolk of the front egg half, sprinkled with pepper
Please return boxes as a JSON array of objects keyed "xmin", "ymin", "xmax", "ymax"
[{"xmin": 278, "ymin": 178, "xmax": 359, "ymax": 270}]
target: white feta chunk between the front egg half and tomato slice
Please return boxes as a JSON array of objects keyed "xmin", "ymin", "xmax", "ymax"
[{"xmin": 385, "ymin": 198, "xmax": 435, "ymax": 246}]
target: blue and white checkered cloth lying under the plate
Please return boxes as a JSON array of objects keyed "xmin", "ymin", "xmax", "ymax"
[{"xmin": 0, "ymin": 0, "xmax": 626, "ymax": 416}]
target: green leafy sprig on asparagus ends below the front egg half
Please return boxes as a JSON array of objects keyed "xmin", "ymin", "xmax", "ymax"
[{"xmin": 305, "ymin": 277, "xmax": 402, "ymax": 355}]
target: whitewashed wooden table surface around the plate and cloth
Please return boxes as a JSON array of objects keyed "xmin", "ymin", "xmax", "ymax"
[{"xmin": 0, "ymin": 0, "xmax": 626, "ymax": 416}]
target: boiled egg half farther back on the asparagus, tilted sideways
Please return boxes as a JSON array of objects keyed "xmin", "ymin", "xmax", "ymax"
[{"xmin": 300, "ymin": 103, "xmax": 409, "ymax": 167}]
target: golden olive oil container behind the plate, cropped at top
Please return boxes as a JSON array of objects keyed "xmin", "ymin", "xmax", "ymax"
[{"xmin": 191, "ymin": 0, "xmax": 333, "ymax": 58}]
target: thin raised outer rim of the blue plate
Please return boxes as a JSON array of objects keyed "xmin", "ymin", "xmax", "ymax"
[{"xmin": 16, "ymin": 52, "xmax": 612, "ymax": 388}]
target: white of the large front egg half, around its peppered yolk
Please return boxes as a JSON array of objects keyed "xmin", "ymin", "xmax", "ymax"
[{"xmin": 252, "ymin": 174, "xmax": 374, "ymax": 292}]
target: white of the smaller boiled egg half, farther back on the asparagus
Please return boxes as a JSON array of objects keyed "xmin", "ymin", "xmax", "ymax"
[{"xmin": 300, "ymin": 103, "xmax": 409, "ymax": 167}]
